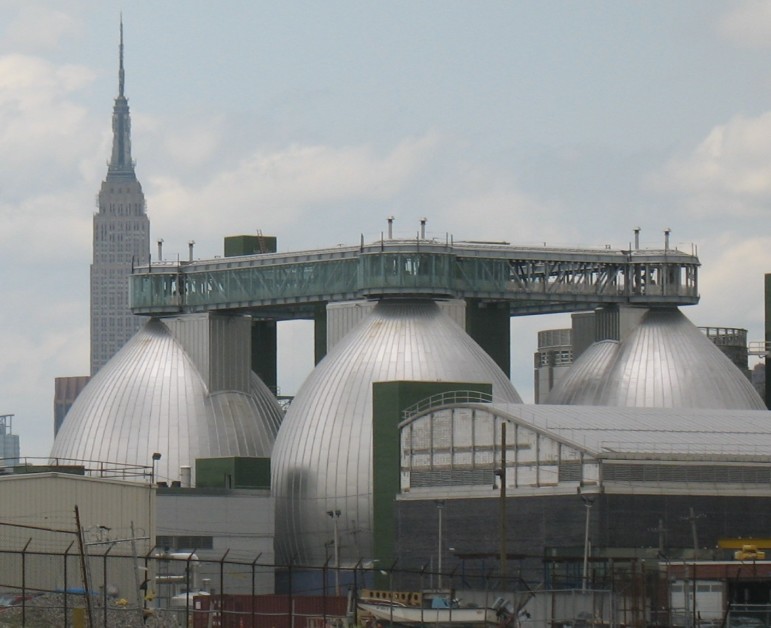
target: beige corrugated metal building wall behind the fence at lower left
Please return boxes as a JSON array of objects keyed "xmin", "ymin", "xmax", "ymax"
[{"xmin": 0, "ymin": 473, "xmax": 155, "ymax": 594}]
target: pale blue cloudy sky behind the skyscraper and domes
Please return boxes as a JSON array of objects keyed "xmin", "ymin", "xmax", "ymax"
[{"xmin": 0, "ymin": 0, "xmax": 771, "ymax": 456}]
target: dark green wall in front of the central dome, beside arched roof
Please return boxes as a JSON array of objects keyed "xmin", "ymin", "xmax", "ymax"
[{"xmin": 372, "ymin": 381, "xmax": 493, "ymax": 565}]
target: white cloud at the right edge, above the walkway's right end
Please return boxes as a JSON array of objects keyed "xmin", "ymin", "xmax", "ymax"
[{"xmin": 653, "ymin": 112, "xmax": 771, "ymax": 216}]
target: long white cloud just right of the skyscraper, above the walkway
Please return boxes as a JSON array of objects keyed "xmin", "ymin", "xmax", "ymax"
[{"xmin": 146, "ymin": 134, "xmax": 440, "ymax": 248}]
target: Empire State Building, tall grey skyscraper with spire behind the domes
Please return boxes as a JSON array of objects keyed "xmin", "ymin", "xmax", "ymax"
[{"xmin": 91, "ymin": 21, "xmax": 150, "ymax": 375}]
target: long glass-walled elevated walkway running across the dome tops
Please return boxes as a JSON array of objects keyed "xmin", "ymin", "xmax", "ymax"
[{"xmin": 130, "ymin": 240, "xmax": 699, "ymax": 320}]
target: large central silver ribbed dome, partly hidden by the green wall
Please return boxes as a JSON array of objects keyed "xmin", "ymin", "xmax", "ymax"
[{"xmin": 272, "ymin": 301, "xmax": 522, "ymax": 564}]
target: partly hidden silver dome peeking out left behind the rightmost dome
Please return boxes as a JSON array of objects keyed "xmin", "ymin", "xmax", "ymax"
[{"xmin": 546, "ymin": 340, "xmax": 619, "ymax": 406}]
